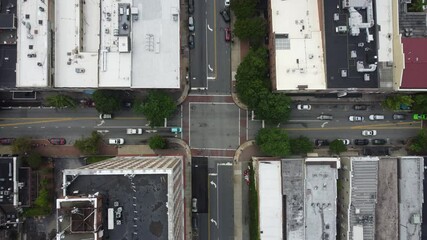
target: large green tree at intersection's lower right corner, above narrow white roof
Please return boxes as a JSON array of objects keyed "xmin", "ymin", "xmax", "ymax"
[{"xmin": 256, "ymin": 128, "xmax": 291, "ymax": 157}]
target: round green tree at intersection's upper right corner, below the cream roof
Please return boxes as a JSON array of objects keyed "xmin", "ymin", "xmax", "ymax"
[{"xmin": 254, "ymin": 92, "xmax": 292, "ymax": 124}]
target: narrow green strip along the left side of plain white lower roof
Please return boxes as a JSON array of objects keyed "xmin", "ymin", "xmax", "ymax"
[{"xmin": 249, "ymin": 161, "xmax": 260, "ymax": 240}]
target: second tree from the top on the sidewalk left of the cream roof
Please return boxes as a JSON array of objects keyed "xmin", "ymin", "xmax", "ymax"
[{"xmin": 234, "ymin": 17, "xmax": 267, "ymax": 46}]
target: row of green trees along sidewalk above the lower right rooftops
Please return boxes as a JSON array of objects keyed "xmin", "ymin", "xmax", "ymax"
[{"xmin": 256, "ymin": 128, "xmax": 350, "ymax": 157}]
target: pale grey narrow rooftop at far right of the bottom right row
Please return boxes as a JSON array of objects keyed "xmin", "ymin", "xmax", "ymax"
[{"xmin": 399, "ymin": 157, "xmax": 424, "ymax": 240}]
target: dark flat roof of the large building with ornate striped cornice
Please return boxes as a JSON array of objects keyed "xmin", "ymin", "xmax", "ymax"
[{"xmin": 65, "ymin": 172, "xmax": 169, "ymax": 240}]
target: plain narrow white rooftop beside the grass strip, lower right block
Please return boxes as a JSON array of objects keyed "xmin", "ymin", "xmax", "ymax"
[{"xmin": 258, "ymin": 161, "xmax": 284, "ymax": 240}]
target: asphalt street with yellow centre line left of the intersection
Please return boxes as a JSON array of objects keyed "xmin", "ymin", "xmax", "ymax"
[{"xmin": 0, "ymin": 108, "xmax": 181, "ymax": 144}]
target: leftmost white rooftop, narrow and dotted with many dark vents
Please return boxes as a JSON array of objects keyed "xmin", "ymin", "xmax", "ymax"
[{"xmin": 16, "ymin": 0, "xmax": 50, "ymax": 87}]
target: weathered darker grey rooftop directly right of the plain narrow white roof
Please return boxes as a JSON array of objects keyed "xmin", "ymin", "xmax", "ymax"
[{"xmin": 282, "ymin": 159, "xmax": 305, "ymax": 240}]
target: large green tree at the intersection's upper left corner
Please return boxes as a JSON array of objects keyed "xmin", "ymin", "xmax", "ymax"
[{"xmin": 139, "ymin": 90, "xmax": 176, "ymax": 127}]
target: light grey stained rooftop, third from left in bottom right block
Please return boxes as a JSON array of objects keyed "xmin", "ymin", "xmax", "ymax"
[{"xmin": 305, "ymin": 158, "xmax": 339, "ymax": 239}]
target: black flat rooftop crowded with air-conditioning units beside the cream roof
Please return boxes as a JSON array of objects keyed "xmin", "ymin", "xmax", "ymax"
[{"xmin": 322, "ymin": 0, "xmax": 382, "ymax": 89}]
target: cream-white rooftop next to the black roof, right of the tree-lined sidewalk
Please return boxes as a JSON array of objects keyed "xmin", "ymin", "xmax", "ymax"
[{"xmin": 271, "ymin": 0, "xmax": 326, "ymax": 90}]
